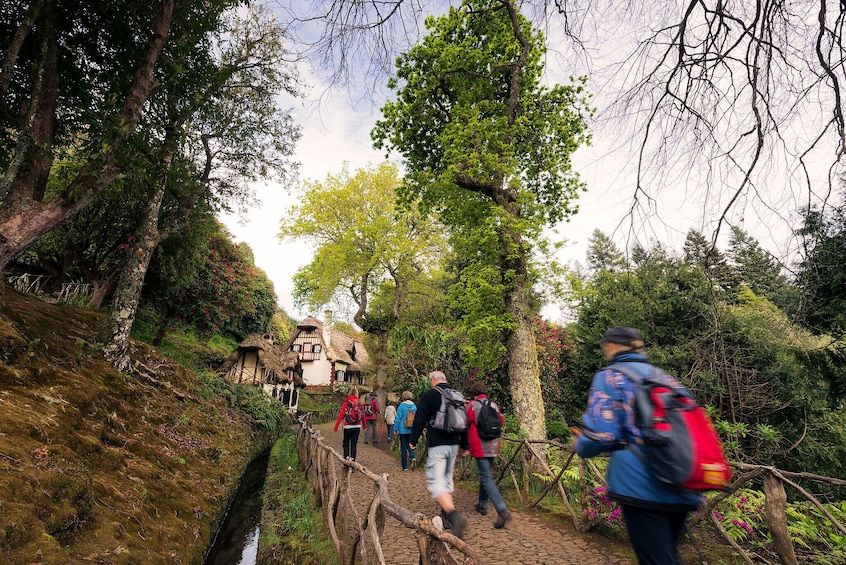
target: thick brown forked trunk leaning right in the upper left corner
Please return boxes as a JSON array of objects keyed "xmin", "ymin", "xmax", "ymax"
[{"xmin": 0, "ymin": 0, "xmax": 174, "ymax": 280}]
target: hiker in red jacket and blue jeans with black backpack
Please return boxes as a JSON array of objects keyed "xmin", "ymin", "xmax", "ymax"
[{"xmin": 460, "ymin": 382, "xmax": 511, "ymax": 529}]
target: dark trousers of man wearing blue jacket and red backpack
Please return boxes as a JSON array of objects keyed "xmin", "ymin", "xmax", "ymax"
[{"xmin": 622, "ymin": 504, "xmax": 687, "ymax": 565}]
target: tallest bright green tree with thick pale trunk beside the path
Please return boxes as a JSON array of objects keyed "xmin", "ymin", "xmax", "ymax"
[{"xmin": 372, "ymin": 0, "xmax": 590, "ymax": 438}]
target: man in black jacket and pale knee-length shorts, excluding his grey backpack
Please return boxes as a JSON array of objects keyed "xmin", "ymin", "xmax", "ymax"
[{"xmin": 409, "ymin": 371, "xmax": 467, "ymax": 539}]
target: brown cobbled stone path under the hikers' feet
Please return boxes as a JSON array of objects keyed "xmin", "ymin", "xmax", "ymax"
[{"xmin": 317, "ymin": 424, "xmax": 635, "ymax": 565}]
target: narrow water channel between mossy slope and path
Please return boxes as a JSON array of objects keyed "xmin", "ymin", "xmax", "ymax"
[{"xmin": 203, "ymin": 453, "xmax": 270, "ymax": 565}]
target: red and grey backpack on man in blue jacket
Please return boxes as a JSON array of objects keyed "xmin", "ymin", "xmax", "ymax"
[{"xmin": 607, "ymin": 363, "xmax": 731, "ymax": 491}]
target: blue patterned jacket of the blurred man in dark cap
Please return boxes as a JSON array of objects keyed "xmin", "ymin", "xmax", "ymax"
[{"xmin": 576, "ymin": 352, "xmax": 703, "ymax": 511}]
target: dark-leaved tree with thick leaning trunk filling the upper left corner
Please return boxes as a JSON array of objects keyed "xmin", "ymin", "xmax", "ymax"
[{"xmin": 0, "ymin": 0, "xmax": 177, "ymax": 280}]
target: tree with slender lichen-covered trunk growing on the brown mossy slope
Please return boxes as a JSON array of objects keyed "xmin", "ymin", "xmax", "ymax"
[{"xmin": 99, "ymin": 6, "xmax": 299, "ymax": 370}]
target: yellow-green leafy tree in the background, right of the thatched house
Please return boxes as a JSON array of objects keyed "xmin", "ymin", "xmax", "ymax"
[{"xmin": 279, "ymin": 163, "xmax": 446, "ymax": 398}]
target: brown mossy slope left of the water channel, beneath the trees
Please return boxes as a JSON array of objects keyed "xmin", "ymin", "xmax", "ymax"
[{"xmin": 0, "ymin": 283, "xmax": 272, "ymax": 564}]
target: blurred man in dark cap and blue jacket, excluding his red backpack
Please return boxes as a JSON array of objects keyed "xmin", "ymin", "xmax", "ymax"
[{"xmin": 573, "ymin": 326, "xmax": 703, "ymax": 565}]
